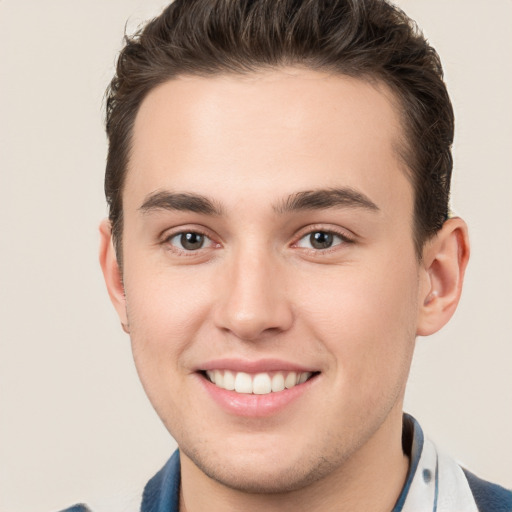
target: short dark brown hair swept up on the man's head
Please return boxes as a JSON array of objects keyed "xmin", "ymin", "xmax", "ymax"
[{"xmin": 105, "ymin": 0, "xmax": 454, "ymax": 262}]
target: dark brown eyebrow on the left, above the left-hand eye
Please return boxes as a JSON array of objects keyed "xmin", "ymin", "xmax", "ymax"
[{"xmin": 139, "ymin": 190, "xmax": 222, "ymax": 215}]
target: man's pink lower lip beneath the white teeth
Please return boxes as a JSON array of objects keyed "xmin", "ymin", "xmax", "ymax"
[{"xmin": 198, "ymin": 375, "xmax": 318, "ymax": 418}]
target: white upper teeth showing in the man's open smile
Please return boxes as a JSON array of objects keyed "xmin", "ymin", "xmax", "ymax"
[{"xmin": 201, "ymin": 370, "xmax": 320, "ymax": 395}]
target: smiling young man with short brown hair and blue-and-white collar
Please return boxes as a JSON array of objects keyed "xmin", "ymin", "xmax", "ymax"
[{"xmin": 71, "ymin": 0, "xmax": 512, "ymax": 512}]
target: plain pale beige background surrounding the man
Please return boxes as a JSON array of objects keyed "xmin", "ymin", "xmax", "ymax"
[{"xmin": 0, "ymin": 0, "xmax": 512, "ymax": 512}]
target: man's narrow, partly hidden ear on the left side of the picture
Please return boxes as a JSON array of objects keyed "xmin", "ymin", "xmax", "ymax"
[{"xmin": 100, "ymin": 219, "xmax": 128, "ymax": 332}]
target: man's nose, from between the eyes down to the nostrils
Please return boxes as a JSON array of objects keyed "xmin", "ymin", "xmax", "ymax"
[{"xmin": 215, "ymin": 247, "xmax": 293, "ymax": 341}]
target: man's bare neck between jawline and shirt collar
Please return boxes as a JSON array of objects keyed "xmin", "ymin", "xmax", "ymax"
[{"xmin": 180, "ymin": 411, "xmax": 409, "ymax": 512}]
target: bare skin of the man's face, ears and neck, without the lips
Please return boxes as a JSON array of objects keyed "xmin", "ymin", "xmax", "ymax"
[{"xmin": 100, "ymin": 68, "xmax": 468, "ymax": 511}]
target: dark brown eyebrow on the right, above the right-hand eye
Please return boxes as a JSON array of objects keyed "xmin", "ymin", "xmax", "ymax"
[{"xmin": 274, "ymin": 187, "xmax": 379, "ymax": 214}]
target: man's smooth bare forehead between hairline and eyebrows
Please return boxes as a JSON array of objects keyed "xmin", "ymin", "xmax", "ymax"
[{"xmin": 125, "ymin": 68, "xmax": 410, "ymax": 214}]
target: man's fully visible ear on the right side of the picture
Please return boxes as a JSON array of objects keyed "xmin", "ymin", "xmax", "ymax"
[{"xmin": 416, "ymin": 217, "xmax": 469, "ymax": 336}]
